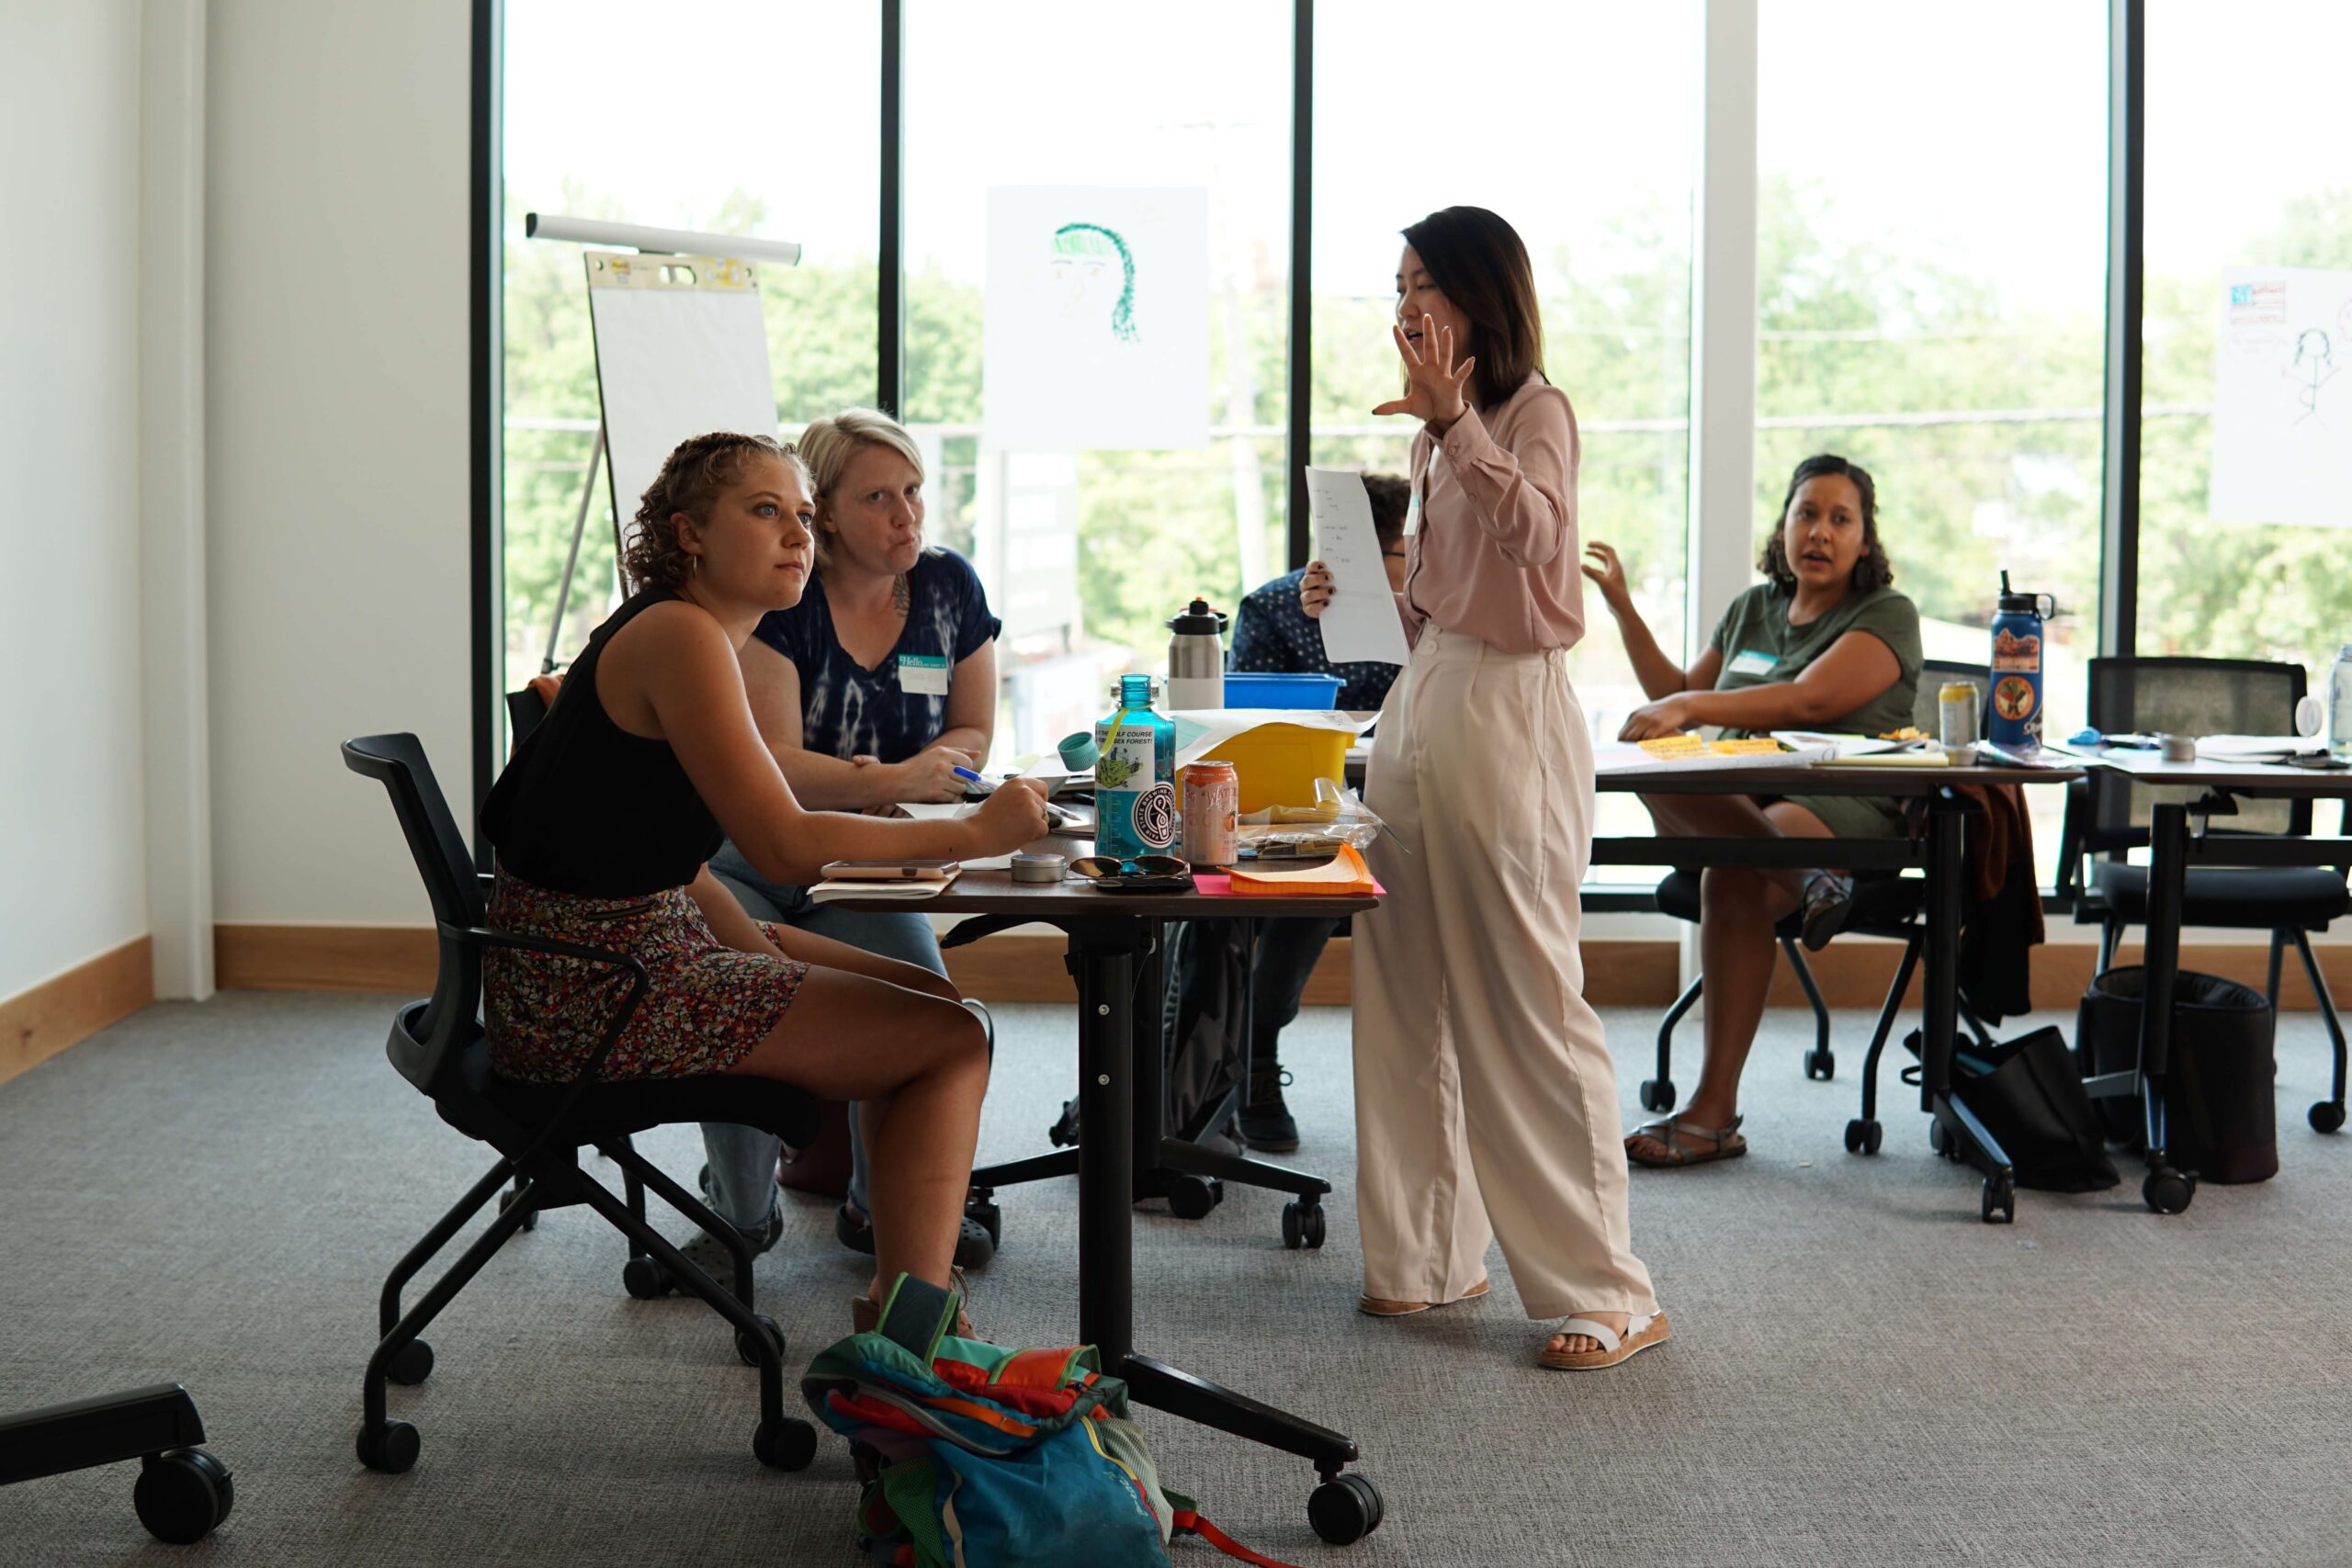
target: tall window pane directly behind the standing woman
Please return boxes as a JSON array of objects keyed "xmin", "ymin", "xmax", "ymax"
[{"xmin": 1310, "ymin": 0, "xmax": 1701, "ymax": 879}]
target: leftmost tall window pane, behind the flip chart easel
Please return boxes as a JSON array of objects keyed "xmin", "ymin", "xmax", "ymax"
[{"xmin": 503, "ymin": 0, "xmax": 882, "ymax": 686}]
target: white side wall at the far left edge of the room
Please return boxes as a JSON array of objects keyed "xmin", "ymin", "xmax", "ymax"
[{"xmin": 0, "ymin": 0, "xmax": 148, "ymax": 997}]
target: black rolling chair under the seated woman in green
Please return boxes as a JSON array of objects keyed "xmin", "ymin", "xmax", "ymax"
[{"xmin": 1642, "ymin": 659, "xmax": 1990, "ymax": 1155}]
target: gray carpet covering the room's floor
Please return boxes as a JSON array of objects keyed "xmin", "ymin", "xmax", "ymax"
[{"xmin": 0, "ymin": 995, "xmax": 2352, "ymax": 1568}]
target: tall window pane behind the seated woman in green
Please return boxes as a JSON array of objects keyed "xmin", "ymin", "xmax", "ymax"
[{"xmin": 1752, "ymin": 0, "xmax": 2108, "ymax": 877}]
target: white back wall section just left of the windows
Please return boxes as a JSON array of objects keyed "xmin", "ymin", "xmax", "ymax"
[{"xmin": 205, "ymin": 0, "xmax": 473, "ymax": 924}]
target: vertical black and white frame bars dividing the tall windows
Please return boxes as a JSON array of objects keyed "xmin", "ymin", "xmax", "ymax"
[{"xmin": 468, "ymin": 0, "xmax": 2147, "ymax": 898}]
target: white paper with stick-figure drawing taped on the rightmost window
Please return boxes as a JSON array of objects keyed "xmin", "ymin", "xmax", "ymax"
[{"xmin": 2206, "ymin": 268, "xmax": 2352, "ymax": 529}]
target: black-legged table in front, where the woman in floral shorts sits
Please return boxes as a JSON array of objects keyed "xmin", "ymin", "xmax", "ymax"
[{"xmin": 837, "ymin": 869, "xmax": 1383, "ymax": 1544}]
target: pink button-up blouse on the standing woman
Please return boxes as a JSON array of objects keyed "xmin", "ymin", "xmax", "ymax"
[{"xmin": 1397, "ymin": 376, "xmax": 1585, "ymax": 653}]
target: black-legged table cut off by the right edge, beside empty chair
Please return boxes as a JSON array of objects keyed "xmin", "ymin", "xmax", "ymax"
[{"xmin": 2065, "ymin": 748, "xmax": 2352, "ymax": 1213}]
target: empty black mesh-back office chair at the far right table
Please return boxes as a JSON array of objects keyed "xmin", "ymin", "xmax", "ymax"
[{"xmin": 2058, "ymin": 659, "xmax": 2352, "ymax": 1134}]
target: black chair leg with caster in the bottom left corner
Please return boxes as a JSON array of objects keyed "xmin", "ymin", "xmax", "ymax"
[{"xmin": 0, "ymin": 1382, "xmax": 238, "ymax": 1547}]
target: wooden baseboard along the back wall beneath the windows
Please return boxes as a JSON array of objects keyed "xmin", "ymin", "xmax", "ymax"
[{"xmin": 211, "ymin": 926, "xmax": 2352, "ymax": 1020}]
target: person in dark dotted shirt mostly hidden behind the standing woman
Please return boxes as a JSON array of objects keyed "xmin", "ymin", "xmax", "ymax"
[{"xmin": 1230, "ymin": 472, "xmax": 1411, "ymax": 1155}]
